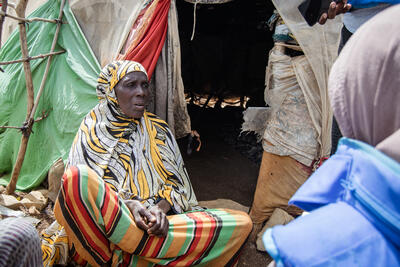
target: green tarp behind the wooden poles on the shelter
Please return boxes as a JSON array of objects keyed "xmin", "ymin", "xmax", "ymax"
[{"xmin": 0, "ymin": 0, "xmax": 100, "ymax": 190}]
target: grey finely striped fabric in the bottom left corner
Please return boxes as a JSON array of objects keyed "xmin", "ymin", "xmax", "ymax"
[{"xmin": 0, "ymin": 218, "xmax": 43, "ymax": 267}]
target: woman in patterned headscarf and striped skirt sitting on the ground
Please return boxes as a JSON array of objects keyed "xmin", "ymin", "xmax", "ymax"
[{"xmin": 42, "ymin": 61, "xmax": 252, "ymax": 266}]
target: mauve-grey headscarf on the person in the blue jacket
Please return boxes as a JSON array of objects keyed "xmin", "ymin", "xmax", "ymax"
[{"xmin": 328, "ymin": 5, "xmax": 400, "ymax": 162}]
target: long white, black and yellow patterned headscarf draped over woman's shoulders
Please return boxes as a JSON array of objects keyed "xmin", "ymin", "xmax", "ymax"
[{"xmin": 67, "ymin": 61, "xmax": 197, "ymax": 213}]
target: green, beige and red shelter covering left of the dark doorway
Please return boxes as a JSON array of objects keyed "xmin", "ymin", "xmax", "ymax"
[{"xmin": 0, "ymin": 0, "xmax": 190, "ymax": 193}]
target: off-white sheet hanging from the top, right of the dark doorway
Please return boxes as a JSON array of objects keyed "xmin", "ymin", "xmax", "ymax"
[{"xmin": 272, "ymin": 0, "xmax": 342, "ymax": 157}]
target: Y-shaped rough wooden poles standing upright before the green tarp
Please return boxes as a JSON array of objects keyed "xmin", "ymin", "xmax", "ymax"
[{"xmin": 6, "ymin": 0, "xmax": 65, "ymax": 194}]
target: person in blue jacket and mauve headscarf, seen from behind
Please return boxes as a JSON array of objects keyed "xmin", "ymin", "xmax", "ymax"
[{"xmin": 263, "ymin": 5, "xmax": 400, "ymax": 266}]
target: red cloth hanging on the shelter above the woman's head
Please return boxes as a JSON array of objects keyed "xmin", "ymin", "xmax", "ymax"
[{"xmin": 122, "ymin": 0, "xmax": 171, "ymax": 79}]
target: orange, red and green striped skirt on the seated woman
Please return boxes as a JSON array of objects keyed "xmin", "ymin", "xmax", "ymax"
[{"xmin": 50, "ymin": 165, "xmax": 252, "ymax": 266}]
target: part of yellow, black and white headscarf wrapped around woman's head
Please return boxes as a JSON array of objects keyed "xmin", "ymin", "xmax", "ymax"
[{"xmin": 96, "ymin": 60, "xmax": 148, "ymax": 114}]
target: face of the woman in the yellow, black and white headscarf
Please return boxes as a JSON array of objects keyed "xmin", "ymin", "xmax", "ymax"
[{"xmin": 114, "ymin": 71, "xmax": 150, "ymax": 119}]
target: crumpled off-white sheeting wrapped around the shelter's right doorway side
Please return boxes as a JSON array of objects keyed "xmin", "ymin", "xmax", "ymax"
[{"xmin": 263, "ymin": 46, "xmax": 321, "ymax": 166}]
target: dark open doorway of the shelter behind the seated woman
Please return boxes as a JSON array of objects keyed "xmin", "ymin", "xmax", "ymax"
[{"xmin": 177, "ymin": 0, "xmax": 274, "ymax": 207}]
